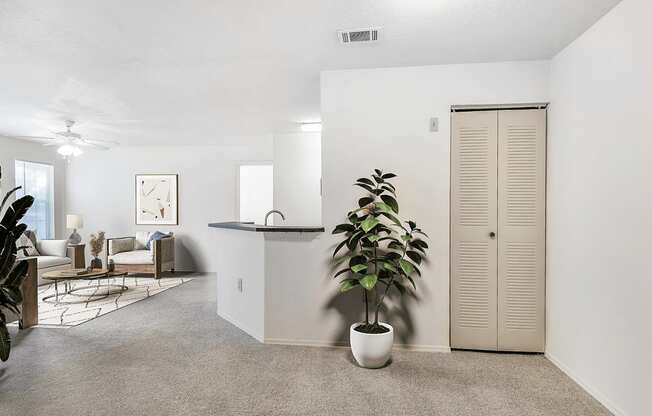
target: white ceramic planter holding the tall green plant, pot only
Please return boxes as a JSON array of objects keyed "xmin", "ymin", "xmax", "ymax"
[{"xmin": 349, "ymin": 322, "xmax": 394, "ymax": 368}]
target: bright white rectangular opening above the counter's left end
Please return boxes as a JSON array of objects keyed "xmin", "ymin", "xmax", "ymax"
[{"xmin": 238, "ymin": 164, "xmax": 274, "ymax": 224}]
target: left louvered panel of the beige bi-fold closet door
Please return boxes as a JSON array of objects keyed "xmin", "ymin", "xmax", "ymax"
[{"xmin": 451, "ymin": 111, "xmax": 497, "ymax": 350}]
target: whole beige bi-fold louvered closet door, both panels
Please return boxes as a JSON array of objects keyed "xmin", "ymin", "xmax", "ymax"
[{"xmin": 451, "ymin": 109, "xmax": 546, "ymax": 352}]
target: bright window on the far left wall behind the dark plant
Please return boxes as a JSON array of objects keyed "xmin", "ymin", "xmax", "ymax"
[{"xmin": 16, "ymin": 160, "xmax": 54, "ymax": 239}]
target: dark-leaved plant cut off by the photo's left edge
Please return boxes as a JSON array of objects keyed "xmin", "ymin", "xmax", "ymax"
[{"xmin": 0, "ymin": 166, "xmax": 34, "ymax": 361}]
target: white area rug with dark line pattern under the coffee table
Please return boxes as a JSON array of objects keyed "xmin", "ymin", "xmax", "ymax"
[{"xmin": 27, "ymin": 277, "xmax": 193, "ymax": 328}]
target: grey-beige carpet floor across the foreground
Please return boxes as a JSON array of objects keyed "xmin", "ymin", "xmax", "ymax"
[{"xmin": 0, "ymin": 275, "xmax": 610, "ymax": 416}]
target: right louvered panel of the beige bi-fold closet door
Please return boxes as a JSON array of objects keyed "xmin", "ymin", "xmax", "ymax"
[{"xmin": 498, "ymin": 110, "xmax": 546, "ymax": 352}]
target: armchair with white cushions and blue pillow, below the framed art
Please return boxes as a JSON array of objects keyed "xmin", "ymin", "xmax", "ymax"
[{"xmin": 106, "ymin": 232, "xmax": 174, "ymax": 279}]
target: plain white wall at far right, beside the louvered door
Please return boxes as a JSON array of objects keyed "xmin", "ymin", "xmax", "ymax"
[{"xmin": 547, "ymin": 0, "xmax": 652, "ymax": 416}]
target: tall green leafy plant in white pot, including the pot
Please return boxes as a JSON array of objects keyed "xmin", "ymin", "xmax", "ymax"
[{"xmin": 333, "ymin": 169, "xmax": 428, "ymax": 368}]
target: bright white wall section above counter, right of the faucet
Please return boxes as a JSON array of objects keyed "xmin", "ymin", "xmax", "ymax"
[{"xmin": 274, "ymin": 133, "xmax": 321, "ymax": 225}]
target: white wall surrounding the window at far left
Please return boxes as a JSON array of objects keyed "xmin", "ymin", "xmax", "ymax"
[{"xmin": 0, "ymin": 137, "xmax": 69, "ymax": 238}]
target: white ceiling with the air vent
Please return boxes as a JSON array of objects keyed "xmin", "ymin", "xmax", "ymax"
[{"xmin": 0, "ymin": 0, "xmax": 619, "ymax": 145}]
